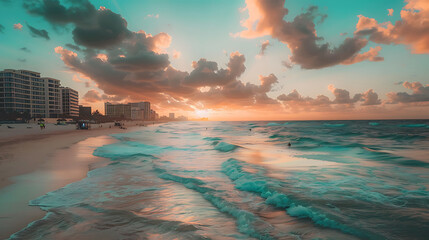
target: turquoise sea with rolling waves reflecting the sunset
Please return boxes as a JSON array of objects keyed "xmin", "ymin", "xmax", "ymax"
[{"xmin": 11, "ymin": 120, "xmax": 429, "ymax": 239}]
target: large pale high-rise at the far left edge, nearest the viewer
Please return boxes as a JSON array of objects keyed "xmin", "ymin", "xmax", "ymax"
[{"xmin": 0, "ymin": 69, "xmax": 49, "ymax": 117}]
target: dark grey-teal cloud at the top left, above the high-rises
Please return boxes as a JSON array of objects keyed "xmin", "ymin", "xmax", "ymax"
[{"xmin": 24, "ymin": 0, "xmax": 132, "ymax": 49}]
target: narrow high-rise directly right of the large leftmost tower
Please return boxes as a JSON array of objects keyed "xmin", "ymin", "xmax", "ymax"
[{"xmin": 41, "ymin": 77, "xmax": 63, "ymax": 118}]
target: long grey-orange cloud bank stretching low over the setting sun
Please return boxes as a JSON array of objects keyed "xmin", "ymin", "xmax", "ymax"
[{"xmin": 56, "ymin": 44, "xmax": 278, "ymax": 110}]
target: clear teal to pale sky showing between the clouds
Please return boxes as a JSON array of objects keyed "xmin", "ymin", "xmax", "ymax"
[{"xmin": 0, "ymin": 0, "xmax": 429, "ymax": 120}]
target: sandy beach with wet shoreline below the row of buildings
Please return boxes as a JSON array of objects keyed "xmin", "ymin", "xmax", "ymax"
[{"xmin": 0, "ymin": 122, "xmax": 160, "ymax": 239}]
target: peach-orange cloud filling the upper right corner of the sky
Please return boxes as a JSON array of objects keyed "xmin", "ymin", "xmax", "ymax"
[{"xmin": 355, "ymin": 0, "xmax": 429, "ymax": 54}]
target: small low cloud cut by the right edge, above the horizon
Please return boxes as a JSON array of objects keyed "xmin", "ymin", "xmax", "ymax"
[{"xmin": 387, "ymin": 81, "xmax": 429, "ymax": 103}]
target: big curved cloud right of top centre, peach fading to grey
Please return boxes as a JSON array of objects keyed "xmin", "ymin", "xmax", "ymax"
[{"xmin": 236, "ymin": 0, "xmax": 382, "ymax": 69}]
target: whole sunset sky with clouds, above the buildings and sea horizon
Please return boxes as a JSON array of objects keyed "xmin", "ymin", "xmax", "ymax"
[{"xmin": 0, "ymin": 0, "xmax": 429, "ymax": 120}]
